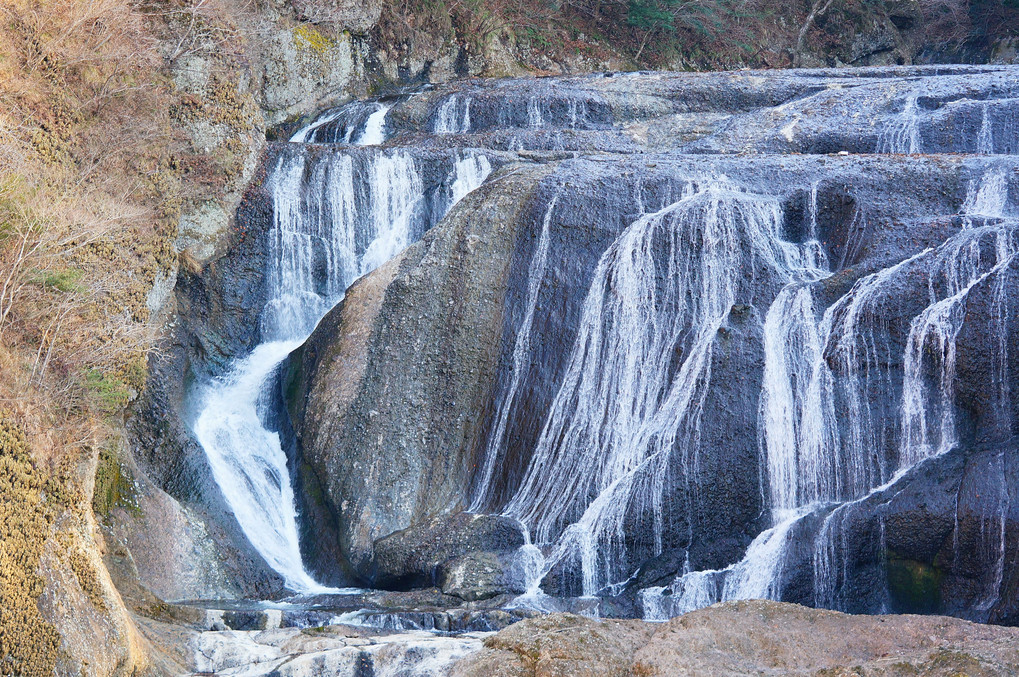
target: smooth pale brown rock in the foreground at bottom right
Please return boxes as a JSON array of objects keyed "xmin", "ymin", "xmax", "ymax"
[{"xmin": 453, "ymin": 601, "xmax": 1019, "ymax": 677}]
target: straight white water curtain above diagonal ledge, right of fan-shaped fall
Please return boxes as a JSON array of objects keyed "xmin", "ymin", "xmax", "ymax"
[{"xmin": 758, "ymin": 245, "xmax": 915, "ymax": 519}]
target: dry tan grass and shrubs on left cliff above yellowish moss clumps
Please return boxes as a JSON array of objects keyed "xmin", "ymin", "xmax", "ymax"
[{"xmin": 0, "ymin": 0, "xmax": 179, "ymax": 448}]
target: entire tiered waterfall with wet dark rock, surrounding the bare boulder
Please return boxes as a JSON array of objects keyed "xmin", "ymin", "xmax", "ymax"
[{"xmin": 167, "ymin": 69, "xmax": 1019, "ymax": 674}]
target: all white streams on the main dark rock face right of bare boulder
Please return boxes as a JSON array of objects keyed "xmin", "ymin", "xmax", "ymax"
[{"xmin": 466, "ymin": 155, "xmax": 1016, "ymax": 619}]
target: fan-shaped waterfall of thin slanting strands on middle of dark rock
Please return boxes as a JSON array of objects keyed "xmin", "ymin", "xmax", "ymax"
[{"xmin": 506, "ymin": 179, "xmax": 805, "ymax": 594}]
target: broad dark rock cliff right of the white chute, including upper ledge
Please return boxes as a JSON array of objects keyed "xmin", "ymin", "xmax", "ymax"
[{"xmin": 288, "ymin": 67, "xmax": 1019, "ymax": 619}]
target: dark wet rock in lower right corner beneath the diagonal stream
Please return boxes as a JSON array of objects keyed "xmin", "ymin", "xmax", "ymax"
[{"xmin": 783, "ymin": 440, "xmax": 1019, "ymax": 625}]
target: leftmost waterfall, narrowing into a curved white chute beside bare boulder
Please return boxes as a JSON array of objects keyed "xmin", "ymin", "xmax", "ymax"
[{"xmin": 194, "ymin": 128, "xmax": 491, "ymax": 592}]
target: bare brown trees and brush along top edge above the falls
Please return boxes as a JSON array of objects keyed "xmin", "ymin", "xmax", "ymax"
[{"xmin": 381, "ymin": 0, "xmax": 1019, "ymax": 69}]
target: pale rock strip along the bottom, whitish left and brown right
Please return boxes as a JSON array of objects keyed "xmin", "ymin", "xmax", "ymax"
[{"xmin": 141, "ymin": 601, "xmax": 1019, "ymax": 677}]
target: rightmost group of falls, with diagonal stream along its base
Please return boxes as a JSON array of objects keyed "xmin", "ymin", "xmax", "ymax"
[{"xmin": 639, "ymin": 161, "xmax": 1019, "ymax": 620}]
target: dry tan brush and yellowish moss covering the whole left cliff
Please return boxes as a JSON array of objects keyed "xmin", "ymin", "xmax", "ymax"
[{"xmin": 0, "ymin": 0, "xmax": 180, "ymax": 664}]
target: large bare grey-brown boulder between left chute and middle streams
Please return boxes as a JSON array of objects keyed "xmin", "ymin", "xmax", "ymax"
[{"xmin": 291, "ymin": 161, "xmax": 547, "ymax": 575}]
